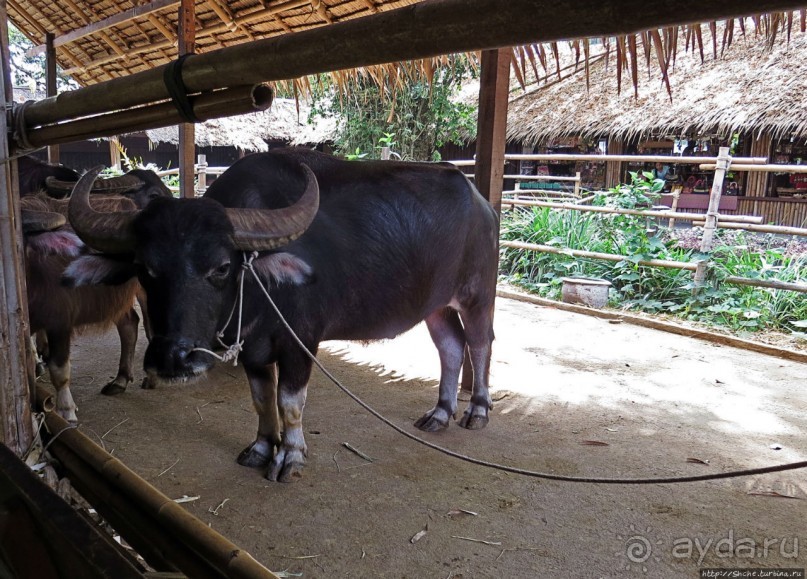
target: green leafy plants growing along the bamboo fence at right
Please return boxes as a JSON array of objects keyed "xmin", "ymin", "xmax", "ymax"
[{"xmin": 500, "ymin": 173, "xmax": 807, "ymax": 335}]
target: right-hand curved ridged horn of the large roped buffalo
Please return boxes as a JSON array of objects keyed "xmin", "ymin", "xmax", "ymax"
[{"xmin": 227, "ymin": 164, "xmax": 319, "ymax": 251}]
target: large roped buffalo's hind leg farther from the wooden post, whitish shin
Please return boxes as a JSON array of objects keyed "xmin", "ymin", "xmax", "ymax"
[{"xmin": 415, "ymin": 308, "xmax": 465, "ymax": 432}]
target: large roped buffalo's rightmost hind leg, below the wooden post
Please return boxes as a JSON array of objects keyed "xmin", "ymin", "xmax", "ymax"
[{"xmin": 459, "ymin": 305, "xmax": 493, "ymax": 430}]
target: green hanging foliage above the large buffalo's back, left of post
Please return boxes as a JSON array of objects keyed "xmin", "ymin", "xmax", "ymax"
[{"xmin": 312, "ymin": 56, "xmax": 476, "ymax": 161}]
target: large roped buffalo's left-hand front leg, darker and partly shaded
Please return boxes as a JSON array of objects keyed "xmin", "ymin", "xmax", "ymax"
[{"xmin": 238, "ymin": 364, "xmax": 280, "ymax": 467}]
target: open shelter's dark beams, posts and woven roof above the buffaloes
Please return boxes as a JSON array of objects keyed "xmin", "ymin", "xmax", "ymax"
[{"xmin": 0, "ymin": 0, "xmax": 800, "ymax": 576}]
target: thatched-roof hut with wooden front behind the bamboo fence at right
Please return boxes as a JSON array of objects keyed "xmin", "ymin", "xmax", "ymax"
[{"xmin": 507, "ymin": 15, "xmax": 807, "ymax": 227}]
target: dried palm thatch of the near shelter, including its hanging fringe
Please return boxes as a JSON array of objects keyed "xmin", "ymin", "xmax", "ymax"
[{"xmin": 7, "ymin": 0, "xmax": 804, "ymax": 102}]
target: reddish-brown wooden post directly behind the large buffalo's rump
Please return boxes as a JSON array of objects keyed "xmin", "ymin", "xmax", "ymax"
[{"xmin": 461, "ymin": 48, "xmax": 513, "ymax": 393}]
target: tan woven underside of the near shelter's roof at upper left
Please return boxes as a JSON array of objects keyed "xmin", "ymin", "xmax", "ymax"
[{"xmin": 8, "ymin": 0, "xmax": 416, "ymax": 86}]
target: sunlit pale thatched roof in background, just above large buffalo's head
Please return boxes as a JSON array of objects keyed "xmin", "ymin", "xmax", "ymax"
[{"xmin": 146, "ymin": 98, "xmax": 336, "ymax": 151}]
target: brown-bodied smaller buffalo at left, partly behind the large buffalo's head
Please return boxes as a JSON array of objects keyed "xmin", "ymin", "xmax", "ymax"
[{"xmin": 20, "ymin": 196, "xmax": 139, "ymax": 422}]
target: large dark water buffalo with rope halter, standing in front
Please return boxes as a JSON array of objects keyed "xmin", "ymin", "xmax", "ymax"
[{"xmin": 67, "ymin": 149, "xmax": 498, "ymax": 481}]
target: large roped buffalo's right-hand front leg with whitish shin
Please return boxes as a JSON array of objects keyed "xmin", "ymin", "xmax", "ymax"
[{"xmin": 266, "ymin": 347, "xmax": 316, "ymax": 482}]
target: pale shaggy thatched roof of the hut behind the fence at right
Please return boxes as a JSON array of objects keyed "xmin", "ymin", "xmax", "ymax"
[{"xmin": 507, "ymin": 23, "xmax": 807, "ymax": 145}]
